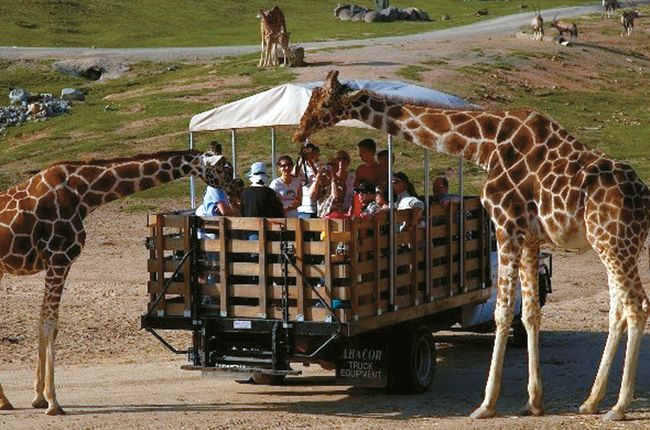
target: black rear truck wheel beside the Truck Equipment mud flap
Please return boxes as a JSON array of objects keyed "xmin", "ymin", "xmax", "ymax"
[{"xmin": 388, "ymin": 326, "xmax": 436, "ymax": 394}]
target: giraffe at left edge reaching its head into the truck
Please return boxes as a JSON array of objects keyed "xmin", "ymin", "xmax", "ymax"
[{"xmin": 0, "ymin": 150, "xmax": 229, "ymax": 415}]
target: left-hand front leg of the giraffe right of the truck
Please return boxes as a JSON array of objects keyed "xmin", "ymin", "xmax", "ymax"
[{"xmin": 470, "ymin": 233, "xmax": 521, "ymax": 418}]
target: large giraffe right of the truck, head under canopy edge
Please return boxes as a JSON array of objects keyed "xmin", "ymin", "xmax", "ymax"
[{"xmin": 293, "ymin": 71, "xmax": 650, "ymax": 420}]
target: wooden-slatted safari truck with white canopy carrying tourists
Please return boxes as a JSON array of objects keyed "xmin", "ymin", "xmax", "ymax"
[{"xmin": 141, "ymin": 81, "xmax": 552, "ymax": 393}]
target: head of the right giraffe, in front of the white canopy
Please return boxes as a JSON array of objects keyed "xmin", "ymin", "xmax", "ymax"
[{"xmin": 293, "ymin": 70, "xmax": 365, "ymax": 142}]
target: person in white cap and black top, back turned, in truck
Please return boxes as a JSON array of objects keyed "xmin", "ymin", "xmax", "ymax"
[{"xmin": 241, "ymin": 161, "xmax": 284, "ymax": 218}]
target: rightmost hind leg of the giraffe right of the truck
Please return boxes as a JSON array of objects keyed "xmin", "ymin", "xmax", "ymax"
[{"xmin": 603, "ymin": 264, "xmax": 650, "ymax": 421}]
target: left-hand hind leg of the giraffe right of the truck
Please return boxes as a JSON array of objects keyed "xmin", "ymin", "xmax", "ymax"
[{"xmin": 580, "ymin": 278, "xmax": 626, "ymax": 414}]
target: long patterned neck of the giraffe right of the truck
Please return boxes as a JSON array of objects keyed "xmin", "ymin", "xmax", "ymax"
[{"xmin": 345, "ymin": 94, "xmax": 540, "ymax": 170}]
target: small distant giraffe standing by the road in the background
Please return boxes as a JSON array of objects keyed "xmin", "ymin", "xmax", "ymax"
[{"xmin": 258, "ymin": 6, "xmax": 291, "ymax": 67}]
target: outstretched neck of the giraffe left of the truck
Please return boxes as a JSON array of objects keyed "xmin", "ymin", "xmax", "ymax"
[{"xmin": 57, "ymin": 150, "xmax": 202, "ymax": 217}]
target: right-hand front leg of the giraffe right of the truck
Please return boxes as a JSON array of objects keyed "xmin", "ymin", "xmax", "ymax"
[{"xmin": 519, "ymin": 246, "xmax": 544, "ymax": 416}]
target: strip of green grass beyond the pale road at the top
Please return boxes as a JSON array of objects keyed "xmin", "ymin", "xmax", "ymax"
[{"xmin": 0, "ymin": 0, "xmax": 586, "ymax": 48}]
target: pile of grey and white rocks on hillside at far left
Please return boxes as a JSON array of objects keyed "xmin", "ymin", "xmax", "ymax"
[{"xmin": 0, "ymin": 88, "xmax": 70, "ymax": 133}]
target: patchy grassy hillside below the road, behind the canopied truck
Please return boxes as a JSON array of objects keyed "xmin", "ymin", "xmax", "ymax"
[{"xmin": 0, "ymin": 8, "xmax": 650, "ymax": 210}]
